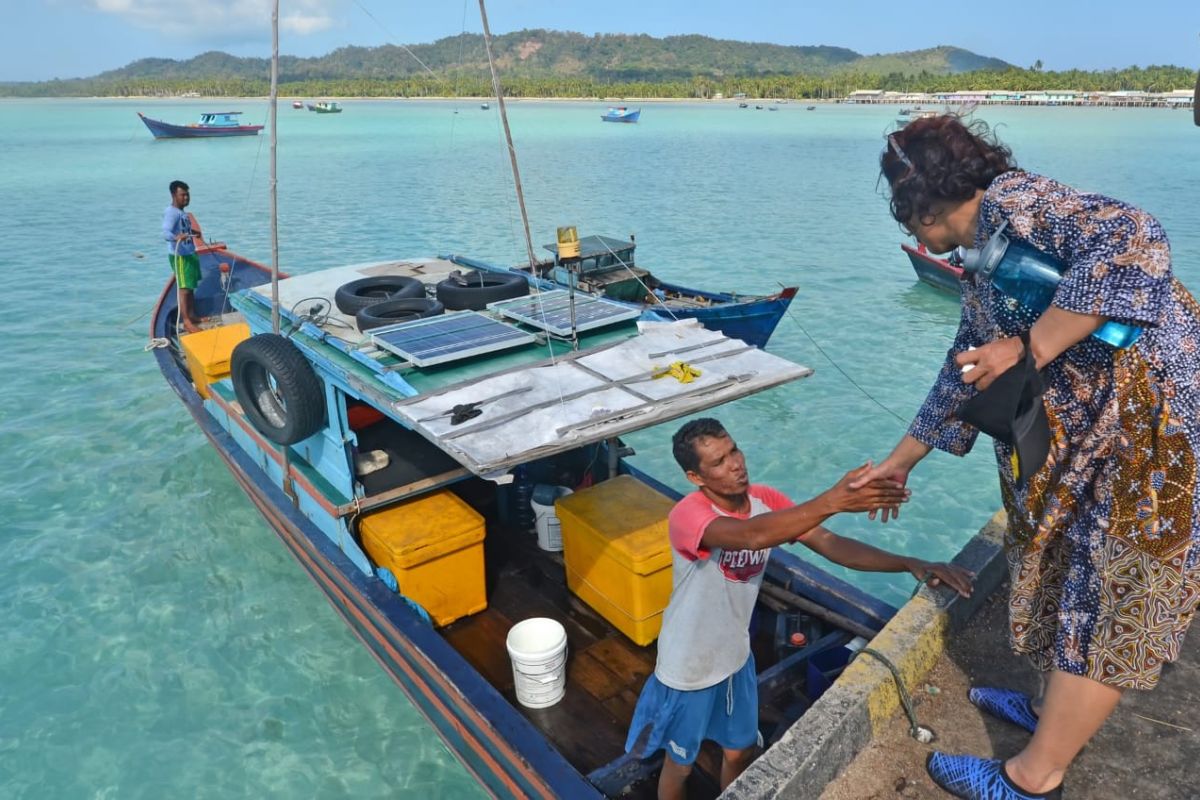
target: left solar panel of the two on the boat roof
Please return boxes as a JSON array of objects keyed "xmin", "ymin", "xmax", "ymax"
[{"xmin": 367, "ymin": 311, "xmax": 536, "ymax": 367}]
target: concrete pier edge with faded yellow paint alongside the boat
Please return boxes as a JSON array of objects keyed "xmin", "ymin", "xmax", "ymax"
[{"xmin": 721, "ymin": 511, "xmax": 1007, "ymax": 800}]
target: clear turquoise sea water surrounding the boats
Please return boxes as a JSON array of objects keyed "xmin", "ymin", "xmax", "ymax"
[{"xmin": 0, "ymin": 101, "xmax": 1200, "ymax": 799}]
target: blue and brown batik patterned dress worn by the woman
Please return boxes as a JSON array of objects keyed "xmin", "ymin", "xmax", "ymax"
[{"xmin": 908, "ymin": 170, "xmax": 1200, "ymax": 688}]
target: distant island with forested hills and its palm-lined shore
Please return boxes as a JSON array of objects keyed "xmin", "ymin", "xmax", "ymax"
[{"xmin": 0, "ymin": 30, "xmax": 1195, "ymax": 98}]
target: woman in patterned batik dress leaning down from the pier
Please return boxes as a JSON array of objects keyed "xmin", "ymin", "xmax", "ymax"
[{"xmin": 864, "ymin": 116, "xmax": 1200, "ymax": 800}]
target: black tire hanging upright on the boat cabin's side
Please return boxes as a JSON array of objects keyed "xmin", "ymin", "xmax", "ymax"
[{"xmin": 229, "ymin": 333, "xmax": 325, "ymax": 445}]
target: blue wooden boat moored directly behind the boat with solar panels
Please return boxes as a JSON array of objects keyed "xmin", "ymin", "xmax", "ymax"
[{"xmin": 446, "ymin": 236, "xmax": 797, "ymax": 348}]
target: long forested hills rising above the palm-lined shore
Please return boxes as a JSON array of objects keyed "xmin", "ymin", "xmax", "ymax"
[{"xmin": 42, "ymin": 30, "xmax": 1010, "ymax": 83}]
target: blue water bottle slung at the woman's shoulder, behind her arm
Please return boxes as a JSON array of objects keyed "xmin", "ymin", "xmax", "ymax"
[{"xmin": 953, "ymin": 221, "xmax": 1141, "ymax": 349}]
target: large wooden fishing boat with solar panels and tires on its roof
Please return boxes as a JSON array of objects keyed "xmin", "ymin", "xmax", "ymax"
[{"xmin": 150, "ymin": 224, "xmax": 895, "ymax": 799}]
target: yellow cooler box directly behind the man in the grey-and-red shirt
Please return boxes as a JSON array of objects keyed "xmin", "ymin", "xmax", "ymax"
[{"xmin": 554, "ymin": 475, "xmax": 674, "ymax": 645}]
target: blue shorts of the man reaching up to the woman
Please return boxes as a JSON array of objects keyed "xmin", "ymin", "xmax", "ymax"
[{"xmin": 625, "ymin": 655, "xmax": 758, "ymax": 765}]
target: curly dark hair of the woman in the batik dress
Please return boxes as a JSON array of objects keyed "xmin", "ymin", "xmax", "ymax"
[{"xmin": 880, "ymin": 114, "xmax": 1016, "ymax": 230}]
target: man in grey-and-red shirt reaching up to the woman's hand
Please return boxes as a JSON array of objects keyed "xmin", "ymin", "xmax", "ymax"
[{"xmin": 625, "ymin": 419, "xmax": 971, "ymax": 800}]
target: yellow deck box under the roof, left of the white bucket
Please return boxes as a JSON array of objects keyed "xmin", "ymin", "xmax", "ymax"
[{"xmin": 359, "ymin": 489, "xmax": 487, "ymax": 626}]
